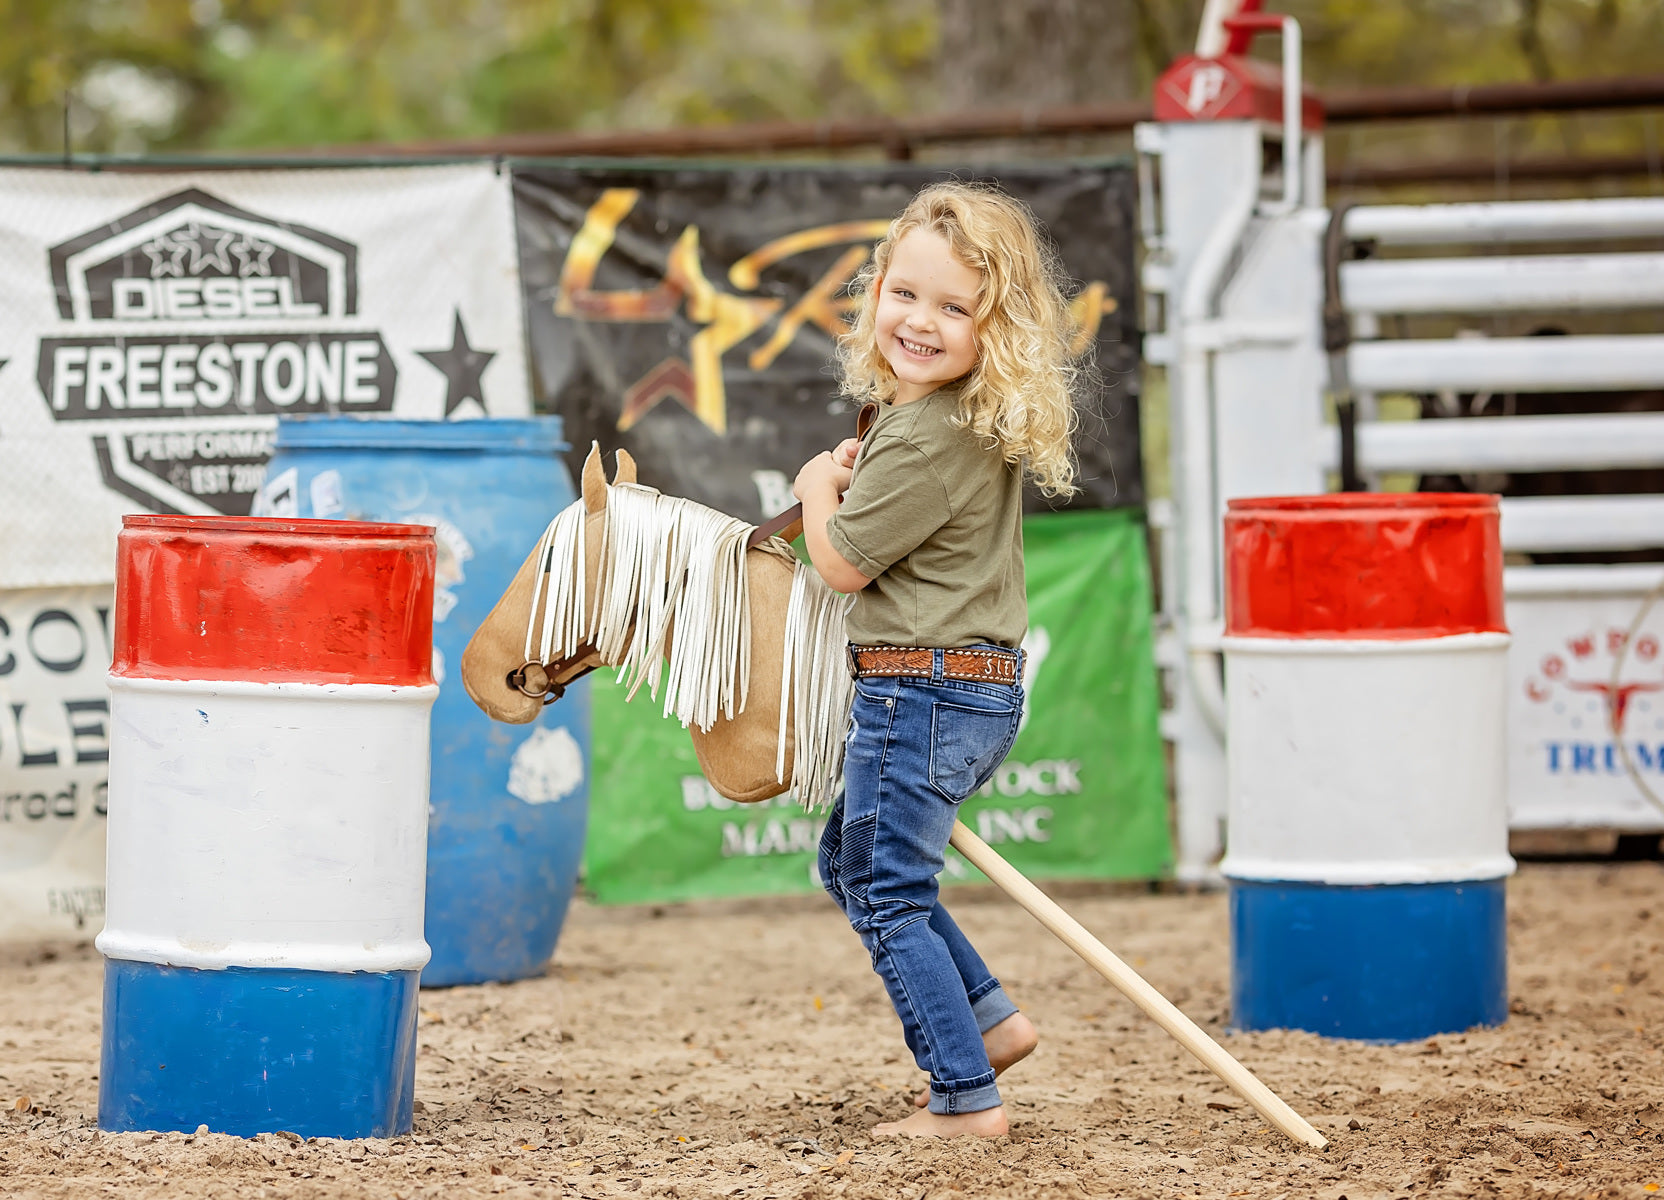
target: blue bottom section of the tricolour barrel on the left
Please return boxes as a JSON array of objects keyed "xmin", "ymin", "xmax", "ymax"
[{"xmin": 98, "ymin": 959, "xmax": 418, "ymax": 1138}]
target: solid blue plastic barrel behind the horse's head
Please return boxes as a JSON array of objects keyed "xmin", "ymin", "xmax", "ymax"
[{"xmin": 261, "ymin": 416, "xmax": 589, "ymax": 987}]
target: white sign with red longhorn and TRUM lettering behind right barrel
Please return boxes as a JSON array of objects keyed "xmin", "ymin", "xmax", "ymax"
[{"xmin": 1508, "ymin": 589, "xmax": 1664, "ymax": 832}]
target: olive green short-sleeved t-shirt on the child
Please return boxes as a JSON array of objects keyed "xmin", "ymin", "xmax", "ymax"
[{"xmin": 827, "ymin": 388, "xmax": 1028, "ymax": 647}]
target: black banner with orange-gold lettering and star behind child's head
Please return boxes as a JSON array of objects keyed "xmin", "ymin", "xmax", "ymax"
[{"xmin": 514, "ymin": 165, "xmax": 1143, "ymax": 521}]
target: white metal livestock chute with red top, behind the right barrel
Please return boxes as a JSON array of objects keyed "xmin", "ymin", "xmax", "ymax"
[{"xmin": 1135, "ymin": 0, "xmax": 1664, "ymax": 882}]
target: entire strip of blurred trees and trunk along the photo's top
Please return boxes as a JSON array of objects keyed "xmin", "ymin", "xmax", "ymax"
[{"xmin": 0, "ymin": 0, "xmax": 1664, "ymax": 153}]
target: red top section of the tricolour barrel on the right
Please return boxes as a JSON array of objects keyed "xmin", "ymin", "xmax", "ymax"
[{"xmin": 1225, "ymin": 493, "xmax": 1508, "ymax": 639}]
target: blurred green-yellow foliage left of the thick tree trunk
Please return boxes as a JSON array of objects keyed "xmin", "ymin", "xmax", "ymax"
[{"xmin": 0, "ymin": 0, "xmax": 935, "ymax": 153}]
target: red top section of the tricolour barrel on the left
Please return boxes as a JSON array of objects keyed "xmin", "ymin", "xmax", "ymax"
[{"xmin": 110, "ymin": 516, "xmax": 434, "ymax": 684}]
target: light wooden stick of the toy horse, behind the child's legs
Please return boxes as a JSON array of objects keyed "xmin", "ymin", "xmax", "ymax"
[{"xmin": 950, "ymin": 822, "xmax": 1328, "ymax": 1150}]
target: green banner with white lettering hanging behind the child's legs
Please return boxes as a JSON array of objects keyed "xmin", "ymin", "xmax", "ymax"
[{"xmin": 584, "ymin": 509, "xmax": 1171, "ymax": 904}]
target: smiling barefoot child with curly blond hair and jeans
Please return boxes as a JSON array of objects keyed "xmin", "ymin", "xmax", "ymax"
[{"xmin": 794, "ymin": 183, "xmax": 1075, "ymax": 1137}]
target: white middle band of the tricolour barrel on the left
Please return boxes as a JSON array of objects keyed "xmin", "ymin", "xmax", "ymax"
[{"xmin": 98, "ymin": 676, "xmax": 438, "ymax": 972}]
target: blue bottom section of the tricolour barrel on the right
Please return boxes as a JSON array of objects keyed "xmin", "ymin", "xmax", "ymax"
[{"xmin": 1230, "ymin": 879, "xmax": 1508, "ymax": 1042}]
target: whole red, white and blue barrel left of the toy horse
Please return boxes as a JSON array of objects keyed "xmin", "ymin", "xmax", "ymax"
[{"xmin": 98, "ymin": 516, "xmax": 438, "ymax": 1137}]
